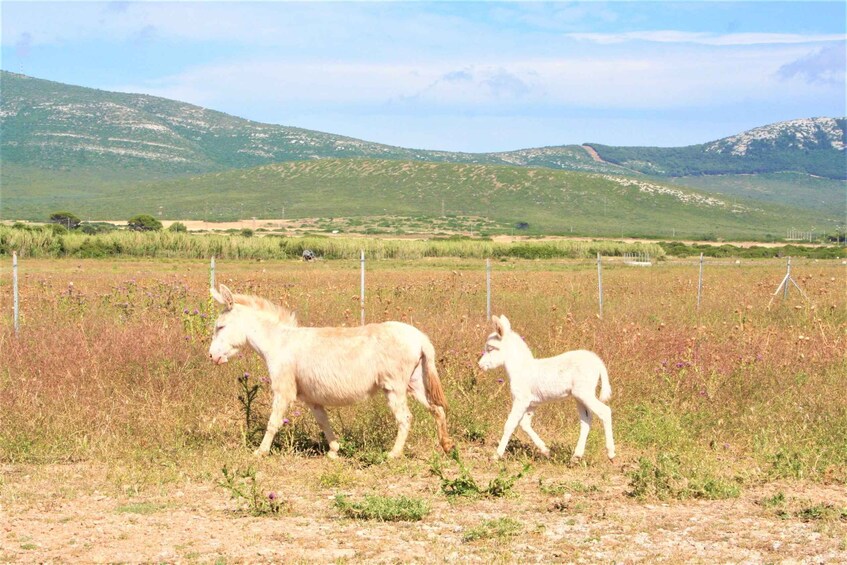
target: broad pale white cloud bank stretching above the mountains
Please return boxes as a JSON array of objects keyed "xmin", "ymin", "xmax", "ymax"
[{"xmin": 112, "ymin": 41, "xmax": 837, "ymax": 118}]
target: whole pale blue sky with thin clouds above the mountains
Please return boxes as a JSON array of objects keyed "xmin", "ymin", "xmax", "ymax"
[{"xmin": 0, "ymin": 0, "xmax": 847, "ymax": 152}]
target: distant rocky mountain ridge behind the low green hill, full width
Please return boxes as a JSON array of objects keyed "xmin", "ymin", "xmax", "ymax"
[{"xmin": 0, "ymin": 71, "xmax": 847, "ymax": 179}]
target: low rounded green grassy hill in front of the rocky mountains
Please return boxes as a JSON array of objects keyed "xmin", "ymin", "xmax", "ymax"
[{"xmin": 4, "ymin": 159, "xmax": 825, "ymax": 238}]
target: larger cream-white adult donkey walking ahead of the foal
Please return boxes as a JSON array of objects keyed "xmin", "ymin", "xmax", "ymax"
[{"xmin": 209, "ymin": 285, "xmax": 453, "ymax": 458}]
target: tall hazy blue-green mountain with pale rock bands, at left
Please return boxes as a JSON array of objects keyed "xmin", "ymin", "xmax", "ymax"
[{"xmin": 0, "ymin": 71, "xmax": 620, "ymax": 177}]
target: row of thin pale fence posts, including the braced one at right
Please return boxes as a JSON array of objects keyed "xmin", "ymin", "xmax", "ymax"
[{"xmin": 6, "ymin": 249, "xmax": 808, "ymax": 335}]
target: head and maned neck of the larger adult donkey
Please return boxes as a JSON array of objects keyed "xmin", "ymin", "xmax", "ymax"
[{"xmin": 209, "ymin": 285, "xmax": 297, "ymax": 365}]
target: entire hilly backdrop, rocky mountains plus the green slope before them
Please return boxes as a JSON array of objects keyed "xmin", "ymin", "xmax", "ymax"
[{"xmin": 0, "ymin": 71, "xmax": 847, "ymax": 234}]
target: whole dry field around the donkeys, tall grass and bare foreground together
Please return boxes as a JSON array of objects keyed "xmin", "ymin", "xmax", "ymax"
[{"xmin": 0, "ymin": 259, "xmax": 847, "ymax": 563}]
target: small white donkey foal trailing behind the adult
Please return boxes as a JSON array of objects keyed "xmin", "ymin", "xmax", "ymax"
[{"xmin": 479, "ymin": 316, "xmax": 615, "ymax": 459}]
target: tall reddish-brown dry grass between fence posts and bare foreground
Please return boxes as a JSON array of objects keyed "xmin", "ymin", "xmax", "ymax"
[{"xmin": 0, "ymin": 260, "xmax": 847, "ymax": 483}]
